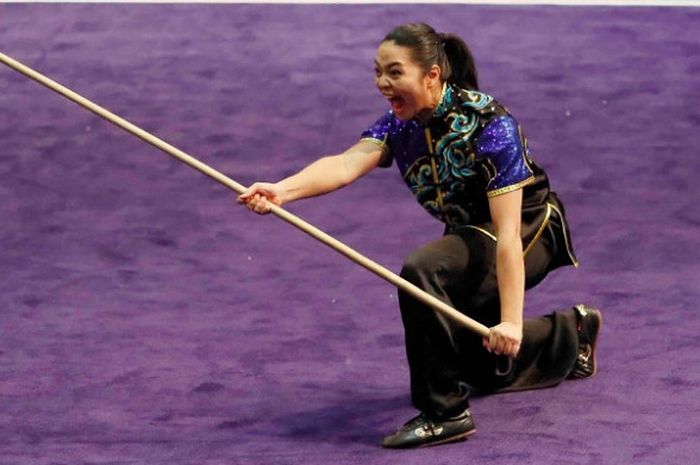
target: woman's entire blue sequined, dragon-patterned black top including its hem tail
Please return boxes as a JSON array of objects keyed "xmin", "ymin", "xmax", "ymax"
[{"xmin": 362, "ymin": 83, "xmax": 577, "ymax": 264}]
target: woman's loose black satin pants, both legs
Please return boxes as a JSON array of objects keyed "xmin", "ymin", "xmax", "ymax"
[{"xmin": 399, "ymin": 228, "xmax": 578, "ymax": 416}]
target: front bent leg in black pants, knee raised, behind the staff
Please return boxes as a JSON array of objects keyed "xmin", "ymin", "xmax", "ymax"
[{"xmin": 399, "ymin": 232, "xmax": 493, "ymax": 416}]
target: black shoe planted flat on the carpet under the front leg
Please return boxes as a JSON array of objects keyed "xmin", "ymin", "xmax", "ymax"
[{"xmin": 382, "ymin": 410, "xmax": 476, "ymax": 449}]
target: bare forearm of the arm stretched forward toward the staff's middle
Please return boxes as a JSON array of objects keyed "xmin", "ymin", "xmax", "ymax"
[{"xmin": 277, "ymin": 155, "xmax": 349, "ymax": 203}]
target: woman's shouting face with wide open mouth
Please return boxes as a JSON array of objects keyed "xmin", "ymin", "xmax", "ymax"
[{"xmin": 374, "ymin": 41, "xmax": 442, "ymax": 121}]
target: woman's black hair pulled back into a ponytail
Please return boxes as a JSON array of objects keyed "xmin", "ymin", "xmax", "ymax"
[{"xmin": 382, "ymin": 23, "xmax": 479, "ymax": 90}]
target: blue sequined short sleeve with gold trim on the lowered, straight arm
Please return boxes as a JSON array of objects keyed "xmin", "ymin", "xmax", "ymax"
[{"xmin": 475, "ymin": 116, "xmax": 535, "ymax": 197}]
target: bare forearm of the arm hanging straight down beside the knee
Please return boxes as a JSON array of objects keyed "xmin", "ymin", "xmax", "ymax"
[{"xmin": 496, "ymin": 234, "xmax": 525, "ymax": 328}]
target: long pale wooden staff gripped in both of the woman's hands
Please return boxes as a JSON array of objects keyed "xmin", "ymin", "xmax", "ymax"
[{"xmin": 0, "ymin": 53, "xmax": 489, "ymax": 337}]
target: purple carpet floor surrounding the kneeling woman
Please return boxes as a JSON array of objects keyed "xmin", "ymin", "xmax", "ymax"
[{"xmin": 0, "ymin": 4, "xmax": 700, "ymax": 465}]
